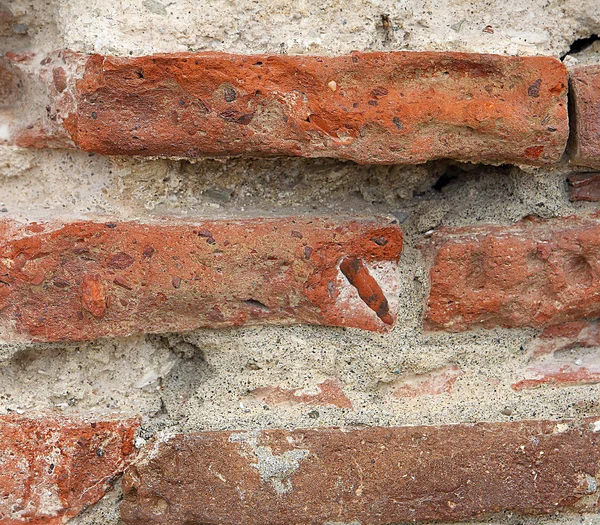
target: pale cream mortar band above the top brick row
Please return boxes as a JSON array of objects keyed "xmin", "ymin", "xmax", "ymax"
[{"xmin": 45, "ymin": 0, "xmax": 600, "ymax": 56}]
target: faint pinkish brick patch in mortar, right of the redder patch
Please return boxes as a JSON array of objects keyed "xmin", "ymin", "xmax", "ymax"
[{"xmin": 386, "ymin": 365, "xmax": 463, "ymax": 398}]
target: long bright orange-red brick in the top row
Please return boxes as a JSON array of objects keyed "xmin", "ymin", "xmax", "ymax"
[{"xmin": 3, "ymin": 52, "xmax": 568, "ymax": 164}]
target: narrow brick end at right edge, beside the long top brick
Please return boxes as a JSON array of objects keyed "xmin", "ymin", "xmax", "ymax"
[{"xmin": 569, "ymin": 65, "xmax": 600, "ymax": 168}]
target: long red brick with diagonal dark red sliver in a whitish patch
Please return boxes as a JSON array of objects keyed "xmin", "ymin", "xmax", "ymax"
[{"xmin": 0, "ymin": 217, "xmax": 402, "ymax": 341}]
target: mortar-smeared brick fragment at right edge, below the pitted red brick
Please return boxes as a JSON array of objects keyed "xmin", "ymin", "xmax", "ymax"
[{"xmin": 512, "ymin": 321, "xmax": 600, "ymax": 390}]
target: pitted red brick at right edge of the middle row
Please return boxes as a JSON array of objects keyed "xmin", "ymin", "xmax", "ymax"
[{"xmin": 422, "ymin": 217, "xmax": 600, "ymax": 331}]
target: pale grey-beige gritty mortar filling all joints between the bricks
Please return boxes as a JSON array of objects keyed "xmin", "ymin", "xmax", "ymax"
[{"xmin": 0, "ymin": 0, "xmax": 600, "ymax": 525}]
